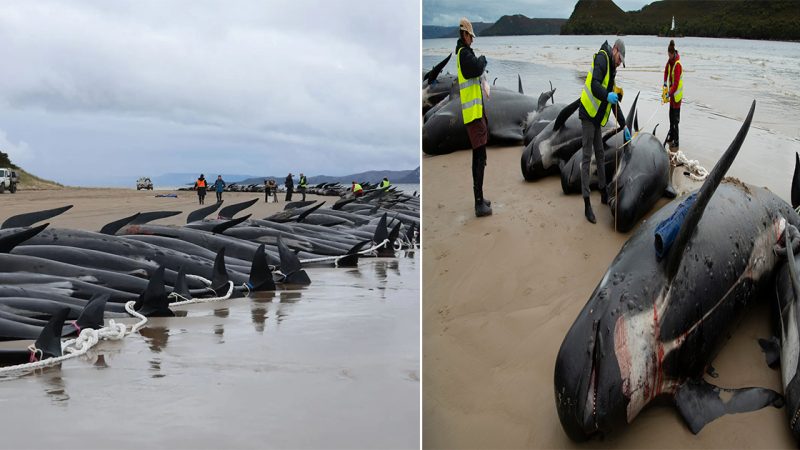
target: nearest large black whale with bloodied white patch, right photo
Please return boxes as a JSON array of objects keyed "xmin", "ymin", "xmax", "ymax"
[{"xmin": 554, "ymin": 101, "xmax": 800, "ymax": 440}]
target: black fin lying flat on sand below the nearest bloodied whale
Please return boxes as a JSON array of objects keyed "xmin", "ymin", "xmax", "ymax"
[{"xmin": 675, "ymin": 379, "xmax": 784, "ymax": 434}]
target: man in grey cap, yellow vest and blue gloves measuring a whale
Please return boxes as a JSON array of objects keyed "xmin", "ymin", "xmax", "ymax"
[{"xmin": 578, "ymin": 39, "xmax": 631, "ymax": 223}]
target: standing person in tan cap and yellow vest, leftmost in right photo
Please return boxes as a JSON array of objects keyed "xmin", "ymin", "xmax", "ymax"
[{"xmin": 456, "ymin": 17, "xmax": 492, "ymax": 217}]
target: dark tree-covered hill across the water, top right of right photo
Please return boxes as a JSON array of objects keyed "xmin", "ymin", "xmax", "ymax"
[{"xmin": 561, "ymin": 0, "xmax": 800, "ymax": 40}]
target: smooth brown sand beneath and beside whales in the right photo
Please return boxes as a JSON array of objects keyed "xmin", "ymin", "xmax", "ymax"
[{"xmin": 422, "ymin": 146, "xmax": 795, "ymax": 448}]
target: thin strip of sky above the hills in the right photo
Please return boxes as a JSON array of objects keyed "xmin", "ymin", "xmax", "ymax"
[{"xmin": 422, "ymin": 0, "xmax": 655, "ymax": 26}]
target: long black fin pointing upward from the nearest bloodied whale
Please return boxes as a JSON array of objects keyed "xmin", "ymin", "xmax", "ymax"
[{"xmin": 666, "ymin": 100, "xmax": 756, "ymax": 280}]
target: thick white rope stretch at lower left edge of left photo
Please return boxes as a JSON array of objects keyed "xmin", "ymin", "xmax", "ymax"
[{"xmin": 0, "ymin": 301, "xmax": 147, "ymax": 374}]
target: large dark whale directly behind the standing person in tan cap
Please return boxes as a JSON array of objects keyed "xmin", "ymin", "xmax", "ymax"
[{"xmin": 422, "ymin": 76, "xmax": 538, "ymax": 155}]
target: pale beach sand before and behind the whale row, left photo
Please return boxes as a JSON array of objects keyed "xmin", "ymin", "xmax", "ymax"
[{"xmin": 0, "ymin": 189, "xmax": 420, "ymax": 449}]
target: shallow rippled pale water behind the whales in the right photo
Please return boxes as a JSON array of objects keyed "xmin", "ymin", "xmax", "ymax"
[{"xmin": 422, "ymin": 36, "xmax": 800, "ymax": 197}]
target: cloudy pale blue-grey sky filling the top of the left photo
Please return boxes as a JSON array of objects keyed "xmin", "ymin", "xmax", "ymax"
[{"xmin": 0, "ymin": 0, "xmax": 420, "ymax": 185}]
